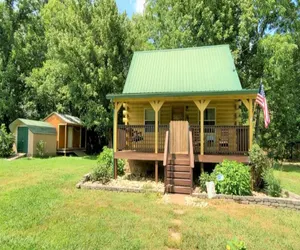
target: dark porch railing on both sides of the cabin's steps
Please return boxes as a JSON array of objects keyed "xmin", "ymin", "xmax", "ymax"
[{"xmin": 117, "ymin": 125, "xmax": 249, "ymax": 155}]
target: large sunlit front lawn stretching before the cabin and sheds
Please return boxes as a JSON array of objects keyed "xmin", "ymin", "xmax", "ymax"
[{"xmin": 0, "ymin": 157, "xmax": 300, "ymax": 250}]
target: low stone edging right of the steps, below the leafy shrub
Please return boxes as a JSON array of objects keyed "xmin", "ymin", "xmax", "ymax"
[{"xmin": 192, "ymin": 193, "xmax": 300, "ymax": 210}]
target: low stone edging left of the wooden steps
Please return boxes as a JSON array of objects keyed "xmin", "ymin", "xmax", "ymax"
[{"xmin": 76, "ymin": 181, "xmax": 164, "ymax": 194}]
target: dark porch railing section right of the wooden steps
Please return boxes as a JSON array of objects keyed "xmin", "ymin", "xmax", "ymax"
[{"xmin": 190, "ymin": 125, "xmax": 249, "ymax": 154}]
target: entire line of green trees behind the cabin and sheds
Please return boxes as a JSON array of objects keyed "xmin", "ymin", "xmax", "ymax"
[{"xmin": 0, "ymin": 0, "xmax": 300, "ymax": 157}]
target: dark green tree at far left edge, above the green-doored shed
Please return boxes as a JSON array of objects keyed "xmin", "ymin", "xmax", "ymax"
[{"xmin": 0, "ymin": 0, "xmax": 46, "ymax": 125}]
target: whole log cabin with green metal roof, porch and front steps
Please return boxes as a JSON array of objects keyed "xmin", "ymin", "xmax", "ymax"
[{"xmin": 107, "ymin": 45, "xmax": 257, "ymax": 193}]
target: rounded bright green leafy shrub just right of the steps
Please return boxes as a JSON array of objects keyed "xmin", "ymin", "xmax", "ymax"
[{"xmin": 211, "ymin": 160, "xmax": 251, "ymax": 195}]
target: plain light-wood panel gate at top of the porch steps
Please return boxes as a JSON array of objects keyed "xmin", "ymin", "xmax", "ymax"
[{"xmin": 169, "ymin": 121, "xmax": 189, "ymax": 154}]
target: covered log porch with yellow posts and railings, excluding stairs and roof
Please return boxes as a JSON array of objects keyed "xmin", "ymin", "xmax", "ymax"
[{"xmin": 113, "ymin": 94, "xmax": 255, "ymax": 182}]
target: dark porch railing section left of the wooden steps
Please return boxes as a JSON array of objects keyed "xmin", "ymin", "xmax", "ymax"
[{"xmin": 117, "ymin": 125, "xmax": 169, "ymax": 153}]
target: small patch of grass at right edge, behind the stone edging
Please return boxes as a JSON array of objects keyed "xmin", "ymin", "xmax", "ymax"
[{"xmin": 274, "ymin": 164, "xmax": 300, "ymax": 195}]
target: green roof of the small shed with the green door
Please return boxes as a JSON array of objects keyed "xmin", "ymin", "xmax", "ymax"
[{"xmin": 9, "ymin": 118, "xmax": 56, "ymax": 135}]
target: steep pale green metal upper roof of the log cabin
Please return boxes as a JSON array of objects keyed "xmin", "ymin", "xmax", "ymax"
[{"xmin": 123, "ymin": 45, "xmax": 242, "ymax": 94}]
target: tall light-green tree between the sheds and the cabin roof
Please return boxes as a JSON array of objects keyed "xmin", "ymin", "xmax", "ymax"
[{"xmin": 26, "ymin": 0, "xmax": 131, "ymax": 137}]
